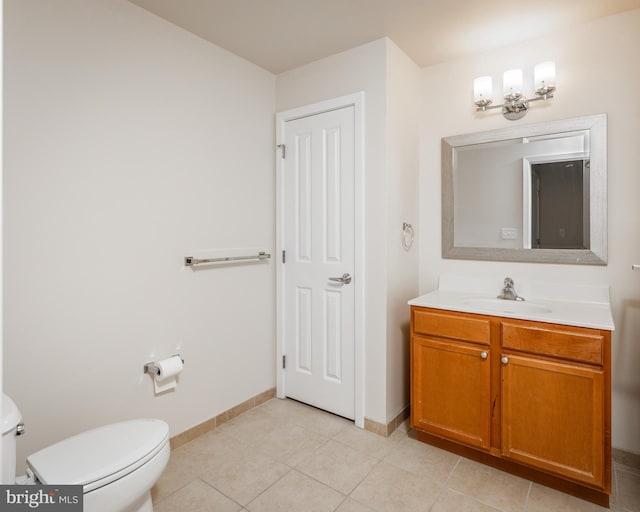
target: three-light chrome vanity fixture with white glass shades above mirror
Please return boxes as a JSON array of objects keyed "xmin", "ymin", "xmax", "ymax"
[{"xmin": 473, "ymin": 61, "xmax": 556, "ymax": 121}]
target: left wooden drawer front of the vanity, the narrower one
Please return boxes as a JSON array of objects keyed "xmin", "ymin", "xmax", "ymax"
[{"xmin": 412, "ymin": 307, "xmax": 491, "ymax": 345}]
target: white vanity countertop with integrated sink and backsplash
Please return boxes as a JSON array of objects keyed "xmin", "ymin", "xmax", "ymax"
[{"xmin": 409, "ymin": 276, "xmax": 615, "ymax": 331}]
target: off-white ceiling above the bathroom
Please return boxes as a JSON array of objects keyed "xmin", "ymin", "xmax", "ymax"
[{"xmin": 129, "ymin": 0, "xmax": 640, "ymax": 74}]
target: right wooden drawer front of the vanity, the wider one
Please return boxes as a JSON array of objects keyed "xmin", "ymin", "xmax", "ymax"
[{"xmin": 501, "ymin": 322, "xmax": 604, "ymax": 365}]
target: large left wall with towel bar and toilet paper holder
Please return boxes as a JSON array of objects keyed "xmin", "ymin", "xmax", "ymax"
[{"xmin": 4, "ymin": 0, "xmax": 275, "ymax": 470}]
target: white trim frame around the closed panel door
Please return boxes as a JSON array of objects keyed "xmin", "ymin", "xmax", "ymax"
[{"xmin": 275, "ymin": 91, "xmax": 365, "ymax": 428}]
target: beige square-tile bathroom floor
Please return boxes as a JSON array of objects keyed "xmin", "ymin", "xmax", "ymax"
[{"xmin": 152, "ymin": 399, "xmax": 640, "ymax": 512}]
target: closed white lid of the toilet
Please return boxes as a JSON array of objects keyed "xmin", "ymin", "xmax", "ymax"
[{"xmin": 27, "ymin": 419, "xmax": 169, "ymax": 493}]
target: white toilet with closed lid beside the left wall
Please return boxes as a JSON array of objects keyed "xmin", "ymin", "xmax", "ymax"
[{"xmin": 0, "ymin": 393, "xmax": 170, "ymax": 512}]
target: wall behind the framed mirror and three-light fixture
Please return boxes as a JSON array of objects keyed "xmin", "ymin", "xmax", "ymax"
[{"xmin": 420, "ymin": 10, "xmax": 640, "ymax": 453}]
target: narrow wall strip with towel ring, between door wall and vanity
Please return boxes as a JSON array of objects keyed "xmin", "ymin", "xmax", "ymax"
[{"xmin": 378, "ymin": 40, "xmax": 421, "ymax": 422}]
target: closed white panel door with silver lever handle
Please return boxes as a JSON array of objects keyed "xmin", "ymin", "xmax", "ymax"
[{"xmin": 283, "ymin": 106, "xmax": 357, "ymax": 419}]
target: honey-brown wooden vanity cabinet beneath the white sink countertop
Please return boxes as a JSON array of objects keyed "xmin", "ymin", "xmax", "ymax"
[{"xmin": 411, "ymin": 306, "xmax": 611, "ymax": 506}]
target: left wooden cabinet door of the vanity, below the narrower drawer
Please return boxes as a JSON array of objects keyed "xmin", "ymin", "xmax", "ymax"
[{"xmin": 411, "ymin": 335, "xmax": 491, "ymax": 450}]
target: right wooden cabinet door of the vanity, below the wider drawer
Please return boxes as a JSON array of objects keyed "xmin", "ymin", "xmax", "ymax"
[{"xmin": 501, "ymin": 353, "xmax": 605, "ymax": 487}]
